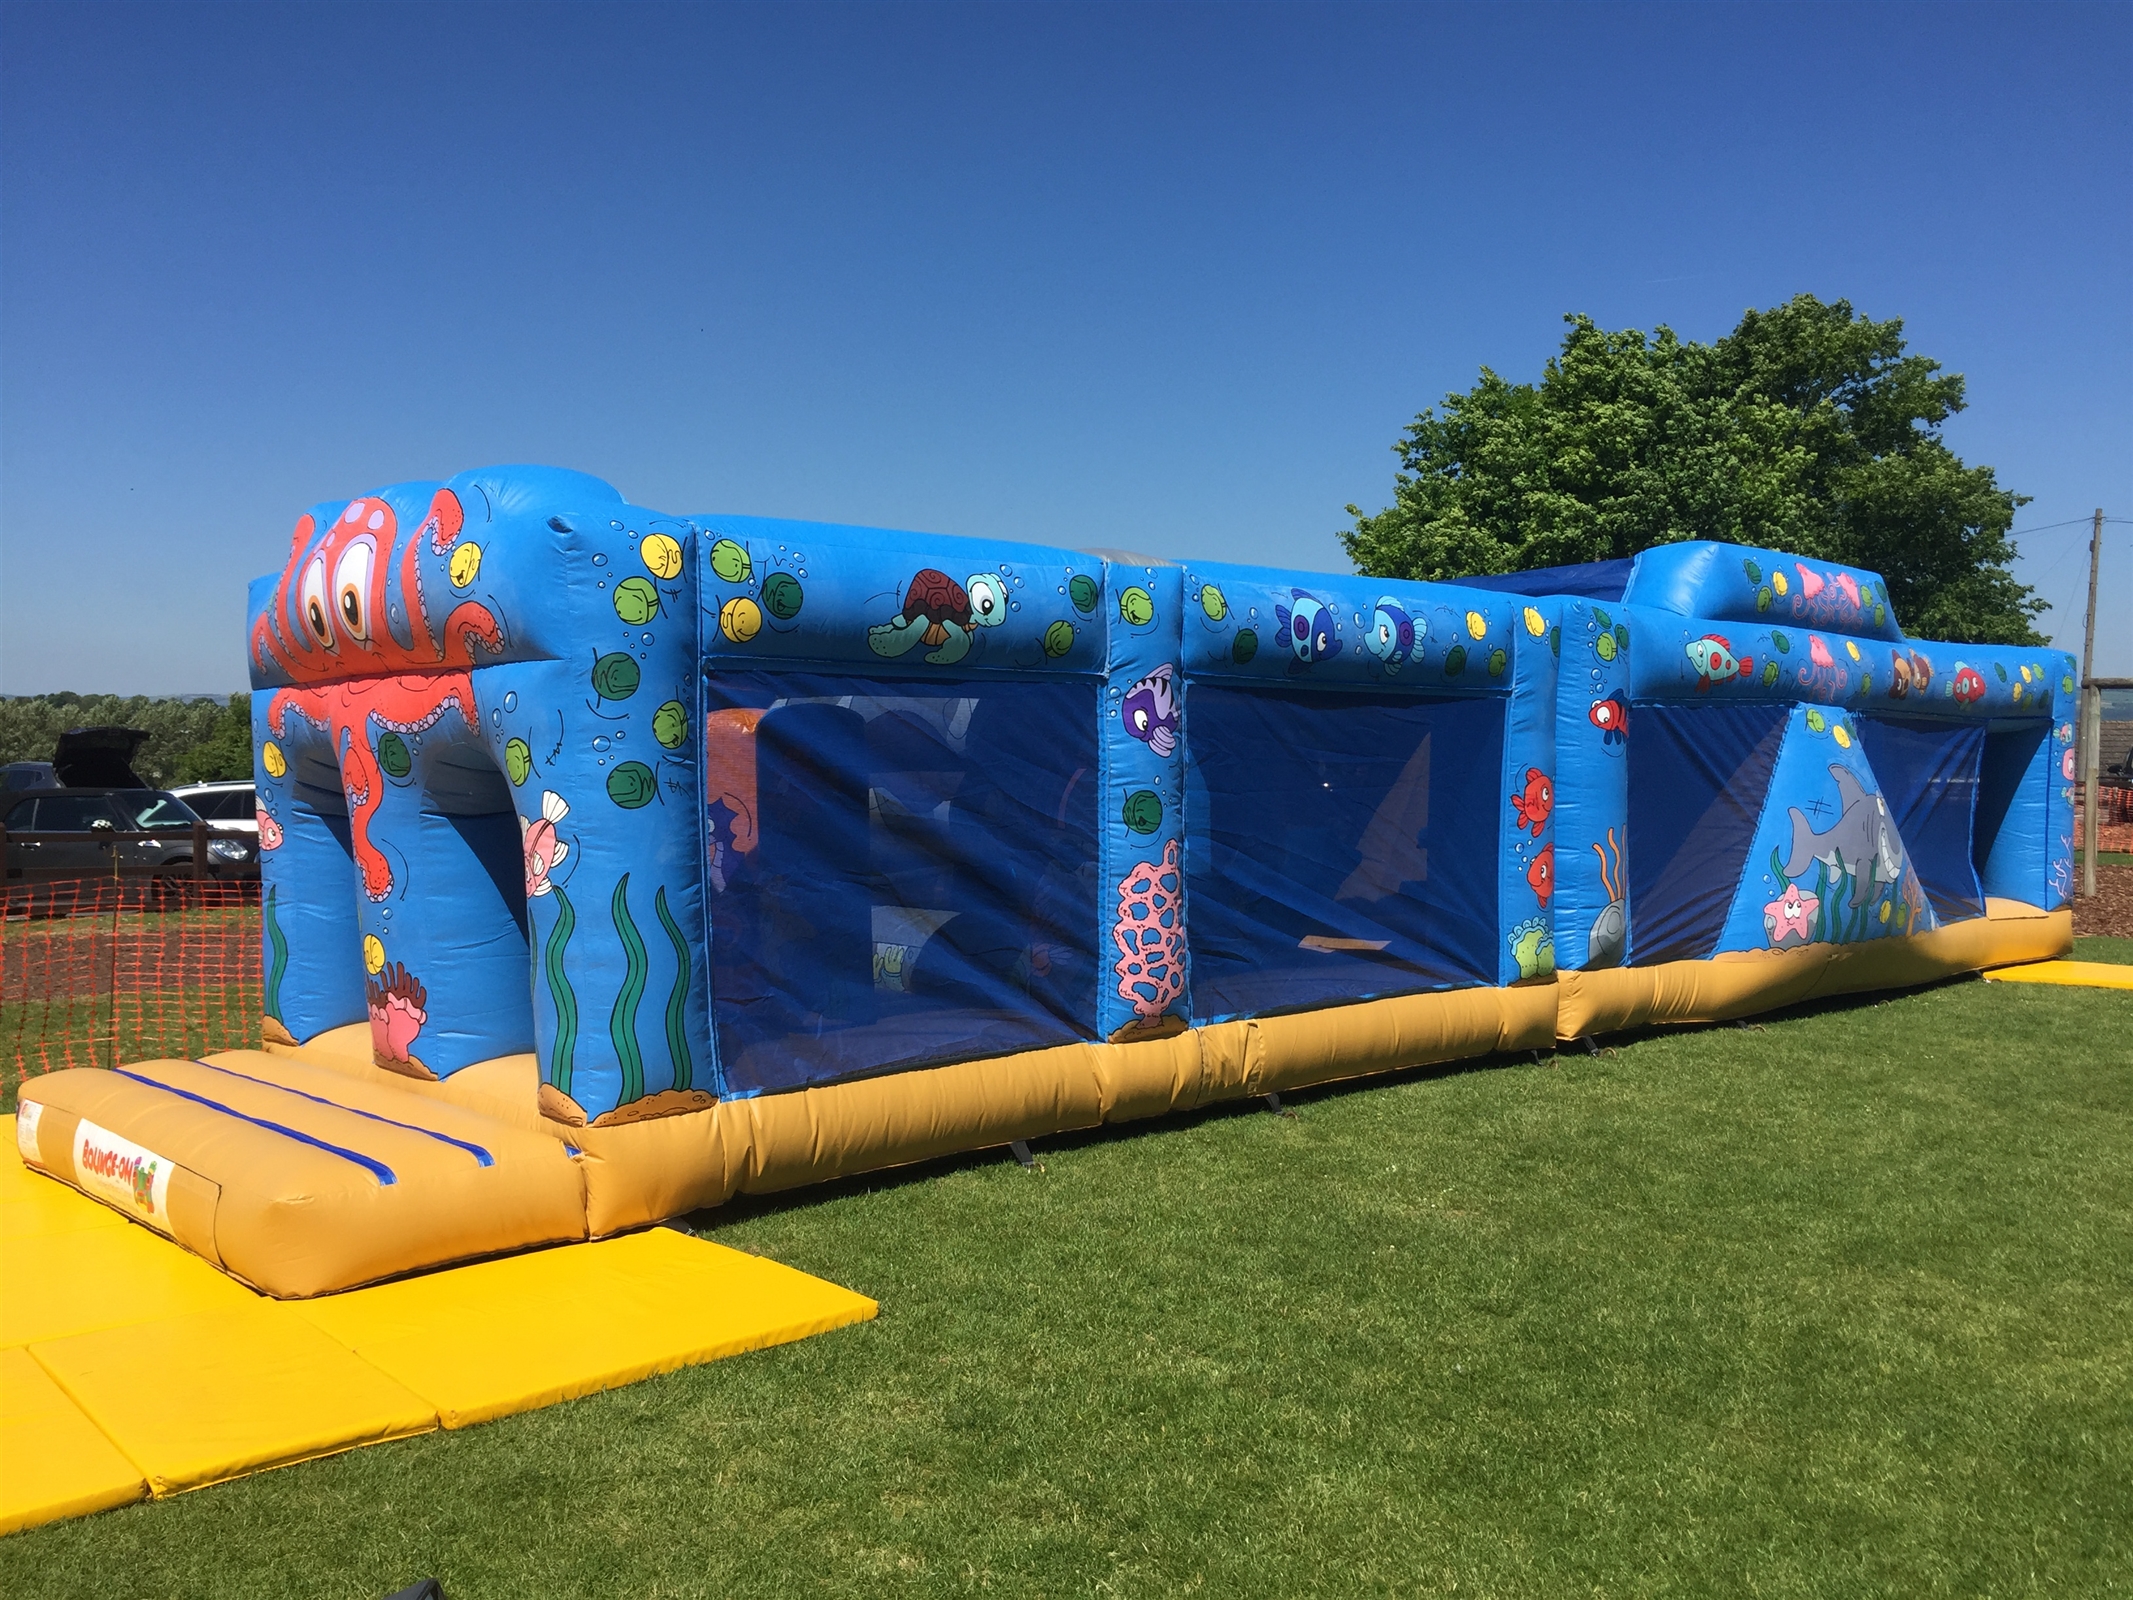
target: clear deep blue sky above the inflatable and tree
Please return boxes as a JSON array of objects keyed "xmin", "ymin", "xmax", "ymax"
[{"xmin": 0, "ymin": 0, "xmax": 2133, "ymax": 693}]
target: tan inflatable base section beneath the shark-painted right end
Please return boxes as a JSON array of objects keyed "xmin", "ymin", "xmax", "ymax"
[{"xmin": 1555, "ymin": 900, "xmax": 2073, "ymax": 1039}]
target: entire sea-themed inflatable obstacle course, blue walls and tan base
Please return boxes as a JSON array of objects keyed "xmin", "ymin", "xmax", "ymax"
[{"xmin": 17, "ymin": 467, "xmax": 2073, "ymax": 1295}]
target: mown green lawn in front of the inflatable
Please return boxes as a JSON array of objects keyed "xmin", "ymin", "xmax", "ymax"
[{"xmin": 0, "ymin": 983, "xmax": 2133, "ymax": 1600}]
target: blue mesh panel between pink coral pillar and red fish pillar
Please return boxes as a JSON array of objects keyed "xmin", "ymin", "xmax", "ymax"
[{"xmin": 1186, "ymin": 681, "xmax": 1504, "ymax": 1018}]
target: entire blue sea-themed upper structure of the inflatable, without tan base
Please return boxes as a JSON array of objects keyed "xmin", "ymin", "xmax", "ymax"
[{"xmin": 252, "ymin": 467, "xmax": 2071, "ymax": 1124}]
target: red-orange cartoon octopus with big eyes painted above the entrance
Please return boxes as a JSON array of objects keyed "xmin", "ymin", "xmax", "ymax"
[{"xmin": 252, "ymin": 489, "xmax": 503, "ymax": 900}]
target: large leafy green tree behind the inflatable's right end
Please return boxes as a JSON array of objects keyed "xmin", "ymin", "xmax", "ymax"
[{"xmin": 1342, "ymin": 294, "xmax": 2043, "ymax": 644}]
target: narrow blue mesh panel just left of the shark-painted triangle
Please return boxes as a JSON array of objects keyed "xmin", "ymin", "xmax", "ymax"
[{"xmin": 1627, "ymin": 704, "xmax": 1790, "ymax": 966}]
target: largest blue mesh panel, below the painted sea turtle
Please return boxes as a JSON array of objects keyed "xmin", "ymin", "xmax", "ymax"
[{"xmin": 706, "ymin": 672, "xmax": 1101, "ymax": 1092}]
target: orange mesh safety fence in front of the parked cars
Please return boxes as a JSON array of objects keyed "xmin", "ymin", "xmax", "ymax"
[{"xmin": 0, "ymin": 877, "xmax": 260, "ymax": 1101}]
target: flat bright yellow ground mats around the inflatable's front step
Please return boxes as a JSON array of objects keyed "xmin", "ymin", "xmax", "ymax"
[{"xmin": 0, "ymin": 1118, "xmax": 877, "ymax": 1534}]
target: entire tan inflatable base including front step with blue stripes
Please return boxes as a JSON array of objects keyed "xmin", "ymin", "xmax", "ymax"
[{"xmin": 0, "ymin": 900, "xmax": 2073, "ymax": 1316}]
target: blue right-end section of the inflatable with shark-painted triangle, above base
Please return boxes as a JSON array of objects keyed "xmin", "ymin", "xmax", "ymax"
[{"xmin": 1485, "ymin": 542, "xmax": 2073, "ymax": 985}]
